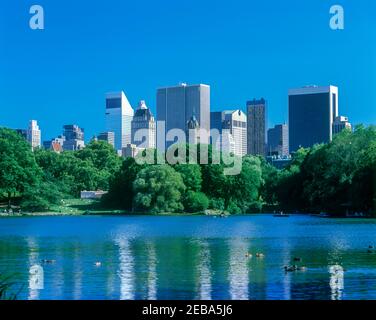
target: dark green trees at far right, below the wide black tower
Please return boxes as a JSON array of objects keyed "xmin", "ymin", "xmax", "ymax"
[{"xmin": 272, "ymin": 126, "xmax": 376, "ymax": 215}]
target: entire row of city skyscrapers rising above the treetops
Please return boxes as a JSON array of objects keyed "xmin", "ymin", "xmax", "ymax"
[{"xmin": 9, "ymin": 83, "xmax": 352, "ymax": 157}]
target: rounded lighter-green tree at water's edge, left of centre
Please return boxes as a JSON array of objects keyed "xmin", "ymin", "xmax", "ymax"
[{"xmin": 133, "ymin": 165, "xmax": 185, "ymax": 213}]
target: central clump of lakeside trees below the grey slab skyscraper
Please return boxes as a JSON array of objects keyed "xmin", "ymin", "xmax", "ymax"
[{"xmin": 104, "ymin": 146, "xmax": 263, "ymax": 213}]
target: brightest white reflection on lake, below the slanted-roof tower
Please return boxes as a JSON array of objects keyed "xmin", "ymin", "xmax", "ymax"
[{"xmin": 115, "ymin": 237, "xmax": 135, "ymax": 300}]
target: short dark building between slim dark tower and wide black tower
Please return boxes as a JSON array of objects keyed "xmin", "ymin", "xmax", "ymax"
[{"xmin": 267, "ymin": 124, "xmax": 289, "ymax": 157}]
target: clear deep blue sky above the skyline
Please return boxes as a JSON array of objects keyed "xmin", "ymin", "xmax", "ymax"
[{"xmin": 0, "ymin": 0, "xmax": 376, "ymax": 140}]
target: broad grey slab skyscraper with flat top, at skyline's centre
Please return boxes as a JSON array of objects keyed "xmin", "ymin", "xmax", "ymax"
[{"xmin": 157, "ymin": 83, "xmax": 210, "ymax": 150}]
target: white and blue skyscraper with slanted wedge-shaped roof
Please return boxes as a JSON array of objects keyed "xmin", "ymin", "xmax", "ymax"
[{"xmin": 106, "ymin": 91, "xmax": 134, "ymax": 151}]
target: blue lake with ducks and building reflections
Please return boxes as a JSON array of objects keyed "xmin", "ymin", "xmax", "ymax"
[{"xmin": 0, "ymin": 215, "xmax": 376, "ymax": 300}]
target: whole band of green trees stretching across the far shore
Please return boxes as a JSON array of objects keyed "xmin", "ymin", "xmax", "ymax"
[{"xmin": 0, "ymin": 126, "xmax": 376, "ymax": 215}]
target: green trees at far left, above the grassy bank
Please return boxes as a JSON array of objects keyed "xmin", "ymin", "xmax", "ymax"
[{"xmin": 0, "ymin": 128, "xmax": 121, "ymax": 210}]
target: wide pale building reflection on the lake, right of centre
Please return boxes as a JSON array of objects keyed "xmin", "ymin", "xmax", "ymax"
[{"xmin": 228, "ymin": 238, "xmax": 249, "ymax": 300}]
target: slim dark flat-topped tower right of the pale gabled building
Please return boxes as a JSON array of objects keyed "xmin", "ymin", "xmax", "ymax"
[{"xmin": 247, "ymin": 99, "xmax": 268, "ymax": 156}]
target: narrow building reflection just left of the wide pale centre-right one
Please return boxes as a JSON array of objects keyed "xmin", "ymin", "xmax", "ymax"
[{"xmin": 197, "ymin": 241, "xmax": 212, "ymax": 300}]
